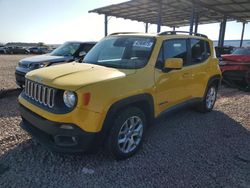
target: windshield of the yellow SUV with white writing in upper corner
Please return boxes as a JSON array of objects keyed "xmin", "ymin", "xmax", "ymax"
[{"xmin": 83, "ymin": 36, "xmax": 154, "ymax": 69}]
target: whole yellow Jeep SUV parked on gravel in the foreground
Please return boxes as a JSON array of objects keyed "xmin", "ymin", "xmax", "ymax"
[{"xmin": 19, "ymin": 32, "xmax": 221, "ymax": 159}]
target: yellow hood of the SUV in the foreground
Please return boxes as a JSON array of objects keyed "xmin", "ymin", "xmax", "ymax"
[{"xmin": 26, "ymin": 62, "xmax": 136, "ymax": 91}]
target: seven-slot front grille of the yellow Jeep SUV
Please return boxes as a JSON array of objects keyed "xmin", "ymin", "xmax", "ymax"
[{"xmin": 24, "ymin": 79, "xmax": 55, "ymax": 108}]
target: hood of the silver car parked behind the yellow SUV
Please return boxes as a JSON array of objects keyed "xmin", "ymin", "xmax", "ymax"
[{"xmin": 20, "ymin": 54, "xmax": 73, "ymax": 65}]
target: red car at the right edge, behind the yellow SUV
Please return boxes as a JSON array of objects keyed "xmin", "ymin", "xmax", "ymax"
[{"xmin": 220, "ymin": 47, "xmax": 250, "ymax": 87}]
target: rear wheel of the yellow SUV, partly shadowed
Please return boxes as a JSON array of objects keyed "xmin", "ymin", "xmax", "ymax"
[{"xmin": 197, "ymin": 84, "xmax": 218, "ymax": 113}]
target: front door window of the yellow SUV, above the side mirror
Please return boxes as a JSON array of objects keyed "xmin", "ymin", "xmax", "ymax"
[{"xmin": 156, "ymin": 39, "xmax": 188, "ymax": 69}]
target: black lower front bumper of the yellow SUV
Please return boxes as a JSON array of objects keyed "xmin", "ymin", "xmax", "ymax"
[{"xmin": 19, "ymin": 105, "xmax": 98, "ymax": 153}]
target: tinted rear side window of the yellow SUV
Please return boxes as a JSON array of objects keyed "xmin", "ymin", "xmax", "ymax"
[{"xmin": 191, "ymin": 39, "xmax": 210, "ymax": 64}]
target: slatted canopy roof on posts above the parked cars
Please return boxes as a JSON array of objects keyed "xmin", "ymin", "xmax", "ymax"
[{"xmin": 89, "ymin": 0, "xmax": 250, "ymax": 27}]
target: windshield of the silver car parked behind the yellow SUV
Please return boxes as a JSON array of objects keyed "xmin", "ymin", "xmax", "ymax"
[{"xmin": 51, "ymin": 42, "xmax": 80, "ymax": 56}]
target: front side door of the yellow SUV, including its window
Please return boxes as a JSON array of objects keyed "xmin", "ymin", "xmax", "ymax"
[{"xmin": 155, "ymin": 39, "xmax": 192, "ymax": 112}]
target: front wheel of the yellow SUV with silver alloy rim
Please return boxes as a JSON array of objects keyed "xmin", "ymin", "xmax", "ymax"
[{"xmin": 107, "ymin": 107, "xmax": 147, "ymax": 160}]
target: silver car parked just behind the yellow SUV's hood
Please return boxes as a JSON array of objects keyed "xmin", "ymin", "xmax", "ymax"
[{"xmin": 15, "ymin": 42, "xmax": 96, "ymax": 87}]
